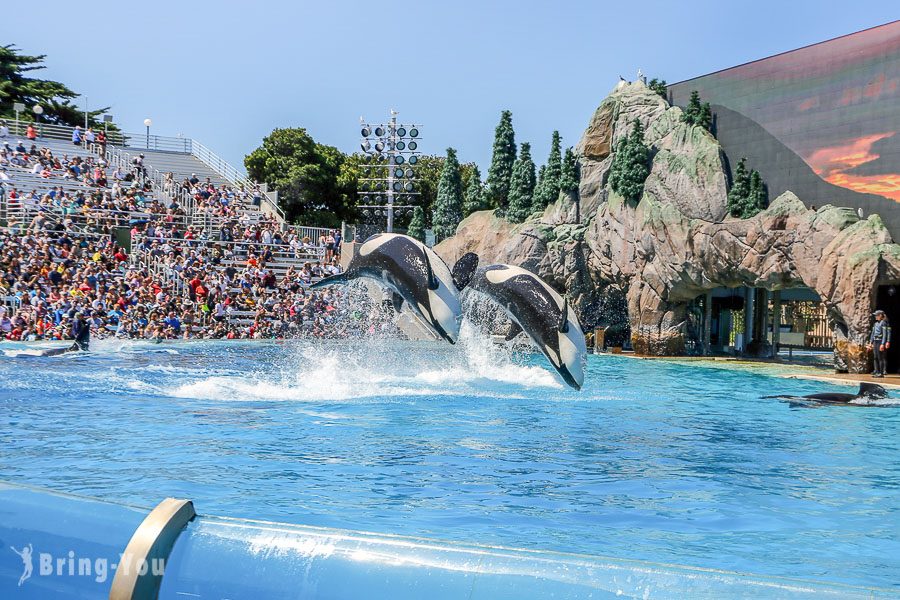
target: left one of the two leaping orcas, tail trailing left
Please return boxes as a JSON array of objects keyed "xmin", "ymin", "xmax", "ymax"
[{"xmin": 311, "ymin": 233, "xmax": 462, "ymax": 344}]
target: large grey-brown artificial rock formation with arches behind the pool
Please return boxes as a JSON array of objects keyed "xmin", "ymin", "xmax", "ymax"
[{"xmin": 435, "ymin": 82, "xmax": 900, "ymax": 372}]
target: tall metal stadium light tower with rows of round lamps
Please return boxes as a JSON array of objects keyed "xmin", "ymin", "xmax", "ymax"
[{"xmin": 357, "ymin": 109, "xmax": 419, "ymax": 233}]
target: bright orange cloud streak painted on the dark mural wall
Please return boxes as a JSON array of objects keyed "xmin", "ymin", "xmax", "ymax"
[{"xmin": 804, "ymin": 131, "xmax": 900, "ymax": 202}]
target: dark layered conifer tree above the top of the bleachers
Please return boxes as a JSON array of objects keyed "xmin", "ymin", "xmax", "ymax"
[{"xmin": 0, "ymin": 44, "xmax": 116, "ymax": 130}]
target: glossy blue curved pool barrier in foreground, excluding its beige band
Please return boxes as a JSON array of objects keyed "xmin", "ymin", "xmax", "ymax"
[{"xmin": 0, "ymin": 483, "xmax": 900, "ymax": 600}]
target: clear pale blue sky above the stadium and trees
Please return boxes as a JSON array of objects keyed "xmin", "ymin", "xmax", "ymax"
[{"xmin": 0, "ymin": 0, "xmax": 900, "ymax": 175}]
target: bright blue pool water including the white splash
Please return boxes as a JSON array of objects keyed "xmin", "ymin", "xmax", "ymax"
[{"xmin": 0, "ymin": 335, "xmax": 900, "ymax": 588}]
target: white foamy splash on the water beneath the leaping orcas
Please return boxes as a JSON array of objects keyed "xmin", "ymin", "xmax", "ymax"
[{"xmin": 158, "ymin": 325, "xmax": 562, "ymax": 402}]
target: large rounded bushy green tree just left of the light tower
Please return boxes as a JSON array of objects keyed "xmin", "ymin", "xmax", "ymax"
[{"xmin": 244, "ymin": 128, "xmax": 365, "ymax": 227}]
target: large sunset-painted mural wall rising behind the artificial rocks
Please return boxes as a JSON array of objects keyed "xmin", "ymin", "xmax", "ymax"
[{"xmin": 669, "ymin": 21, "xmax": 900, "ymax": 240}]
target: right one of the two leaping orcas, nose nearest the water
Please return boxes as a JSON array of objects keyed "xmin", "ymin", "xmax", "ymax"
[{"xmin": 453, "ymin": 252, "xmax": 587, "ymax": 390}]
